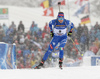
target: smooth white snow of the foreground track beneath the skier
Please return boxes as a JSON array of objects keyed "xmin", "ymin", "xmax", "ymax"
[{"xmin": 0, "ymin": 66, "xmax": 100, "ymax": 79}]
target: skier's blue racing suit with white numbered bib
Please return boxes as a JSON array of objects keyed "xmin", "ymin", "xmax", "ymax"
[{"xmin": 43, "ymin": 19, "xmax": 74, "ymax": 61}]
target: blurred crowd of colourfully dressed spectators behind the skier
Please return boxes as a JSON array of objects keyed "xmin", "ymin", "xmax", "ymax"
[{"xmin": 0, "ymin": 21, "xmax": 100, "ymax": 69}]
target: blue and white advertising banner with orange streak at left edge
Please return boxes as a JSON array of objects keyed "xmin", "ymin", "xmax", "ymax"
[{"xmin": 0, "ymin": 43, "xmax": 16, "ymax": 69}]
